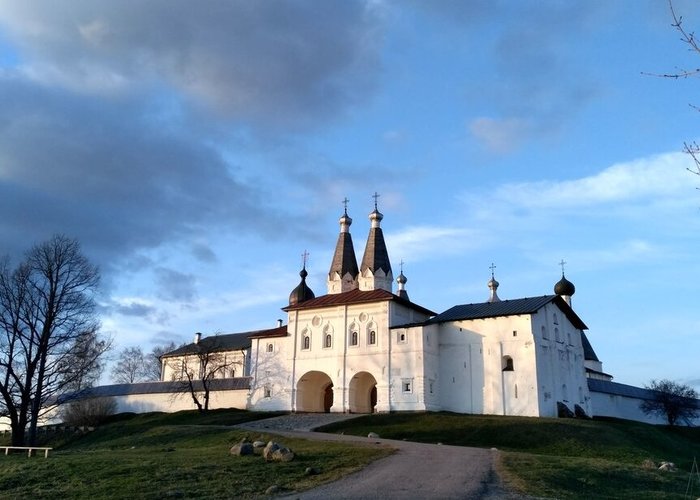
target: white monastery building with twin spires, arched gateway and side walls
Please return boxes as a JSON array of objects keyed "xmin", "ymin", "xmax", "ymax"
[{"xmin": 80, "ymin": 198, "xmax": 696, "ymax": 423}]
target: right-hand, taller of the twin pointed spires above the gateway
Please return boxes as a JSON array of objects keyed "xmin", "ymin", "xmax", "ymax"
[{"xmin": 360, "ymin": 193, "xmax": 394, "ymax": 292}]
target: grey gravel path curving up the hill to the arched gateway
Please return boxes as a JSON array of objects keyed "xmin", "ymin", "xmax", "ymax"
[{"xmin": 235, "ymin": 413, "xmax": 524, "ymax": 500}]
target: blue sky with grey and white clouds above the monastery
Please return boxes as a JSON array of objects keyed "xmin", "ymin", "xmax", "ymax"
[{"xmin": 0, "ymin": 0, "xmax": 700, "ymax": 390}]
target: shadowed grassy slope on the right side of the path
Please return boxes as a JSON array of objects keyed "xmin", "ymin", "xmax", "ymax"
[{"xmin": 323, "ymin": 413, "xmax": 700, "ymax": 499}]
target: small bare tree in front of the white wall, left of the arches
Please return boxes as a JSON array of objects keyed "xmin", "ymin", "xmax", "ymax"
[{"xmin": 166, "ymin": 335, "xmax": 239, "ymax": 413}]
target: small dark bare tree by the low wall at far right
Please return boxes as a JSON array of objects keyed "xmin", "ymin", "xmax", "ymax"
[{"xmin": 639, "ymin": 379, "xmax": 700, "ymax": 425}]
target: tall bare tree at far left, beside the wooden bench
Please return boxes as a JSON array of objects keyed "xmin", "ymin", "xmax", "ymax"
[{"xmin": 0, "ymin": 235, "xmax": 109, "ymax": 446}]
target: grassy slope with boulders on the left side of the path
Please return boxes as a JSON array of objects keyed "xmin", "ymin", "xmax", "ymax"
[{"xmin": 0, "ymin": 410, "xmax": 392, "ymax": 499}]
